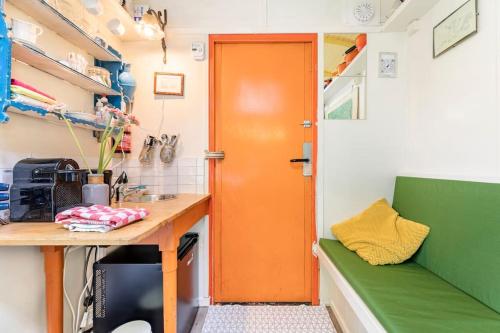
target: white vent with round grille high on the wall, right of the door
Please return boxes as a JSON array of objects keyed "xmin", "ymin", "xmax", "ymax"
[{"xmin": 344, "ymin": 0, "xmax": 380, "ymax": 25}]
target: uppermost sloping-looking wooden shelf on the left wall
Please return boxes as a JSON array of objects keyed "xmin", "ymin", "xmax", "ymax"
[{"xmin": 8, "ymin": 0, "xmax": 121, "ymax": 61}]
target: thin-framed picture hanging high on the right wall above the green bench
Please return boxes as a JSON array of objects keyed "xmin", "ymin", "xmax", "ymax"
[{"xmin": 433, "ymin": 0, "xmax": 478, "ymax": 58}]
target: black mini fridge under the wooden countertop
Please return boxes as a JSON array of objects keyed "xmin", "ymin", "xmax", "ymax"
[{"xmin": 93, "ymin": 233, "xmax": 199, "ymax": 333}]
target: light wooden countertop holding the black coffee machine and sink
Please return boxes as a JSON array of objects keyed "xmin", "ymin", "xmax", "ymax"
[{"xmin": 0, "ymin": 194, "xmax": 210, "ymax": 246}]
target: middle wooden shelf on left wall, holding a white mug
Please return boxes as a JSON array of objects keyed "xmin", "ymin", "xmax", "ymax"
[{"xmin": 12, "ymin": 42, "xmax": 121, "ymax": 96}]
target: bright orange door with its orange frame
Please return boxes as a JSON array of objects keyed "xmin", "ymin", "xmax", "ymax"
[{"xmin": 211, "ymin": 35, "xmax": 316, "ymax": 302}]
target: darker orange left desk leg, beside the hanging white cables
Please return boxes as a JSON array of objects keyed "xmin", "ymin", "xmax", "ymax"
[{"xmin": 42, "ymin": 246, "xmax": 64, "ymax": 333}]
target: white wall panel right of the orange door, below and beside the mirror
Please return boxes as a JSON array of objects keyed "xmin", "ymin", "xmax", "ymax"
[{"xmin": 320, "ymin": 33, "xmax": 408, "ymax": 238}]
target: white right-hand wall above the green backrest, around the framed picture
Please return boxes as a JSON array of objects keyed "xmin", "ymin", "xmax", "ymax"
[{"xmin": 402, "ymin": 0, "xmax": 500, "ymax": 179}]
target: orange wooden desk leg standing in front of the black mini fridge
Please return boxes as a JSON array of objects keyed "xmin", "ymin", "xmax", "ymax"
[{"xmin": 159, "ymin": 224, "xmax": 179, "ymax": 333}]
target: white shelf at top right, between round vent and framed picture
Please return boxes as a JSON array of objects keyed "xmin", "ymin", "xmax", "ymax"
[{"xmin": 382, "ymin": 0, "xmax": 437, "ymax": 32}]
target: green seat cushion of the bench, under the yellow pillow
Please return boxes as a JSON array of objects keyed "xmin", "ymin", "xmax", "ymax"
[{"xmin": 320, "ymin": 239, "xmax": 500, "ymax": 333}]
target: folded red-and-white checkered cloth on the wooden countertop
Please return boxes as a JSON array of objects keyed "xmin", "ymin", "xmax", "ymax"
[{"xmin": 56, "ymin": 205, "xmax": 149, "ymax": 232}]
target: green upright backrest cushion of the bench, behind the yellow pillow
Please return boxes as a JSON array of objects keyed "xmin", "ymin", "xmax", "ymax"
[{"xmin": 393, "ymin": 177, "xmax": 500, "ymax": 312}]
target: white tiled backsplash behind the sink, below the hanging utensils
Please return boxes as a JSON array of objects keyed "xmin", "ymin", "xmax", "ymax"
[{"xmin": 113, "ymin": 157, "xmax": 206, "ymax": 194}]
